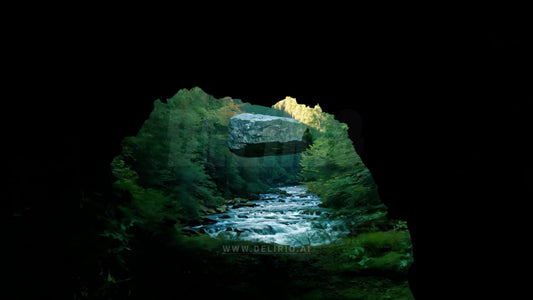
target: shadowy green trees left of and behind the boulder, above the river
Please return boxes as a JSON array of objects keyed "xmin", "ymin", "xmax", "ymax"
[{"xmin": 111, "ymin": 88, "xmax": 301, "ymax": 229}]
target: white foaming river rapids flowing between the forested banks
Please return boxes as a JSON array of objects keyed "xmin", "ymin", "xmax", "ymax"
[{"xmin": 194, "ymin": 186, "xmax": 348, "ymax": 247}]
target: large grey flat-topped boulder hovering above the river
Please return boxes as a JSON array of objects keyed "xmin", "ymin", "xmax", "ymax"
[{"xmin": 228, "ymin": 114, "xmax": 312, "ymax": 157}]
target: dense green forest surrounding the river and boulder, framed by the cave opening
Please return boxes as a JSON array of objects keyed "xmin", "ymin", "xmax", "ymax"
[{"xmin": 71, "ymin": 88, "xmax": 411, "ymax": 299}]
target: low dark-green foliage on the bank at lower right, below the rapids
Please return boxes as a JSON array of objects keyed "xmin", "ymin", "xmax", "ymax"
[{"xmin": 298, "ymin": 235, "xmax": 413, "ymax": 299}]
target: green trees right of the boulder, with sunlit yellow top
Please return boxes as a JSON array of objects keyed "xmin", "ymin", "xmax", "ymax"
[{"xmin": 273, "ymin": 97, "xmax": 380, "ymax": 209}]
